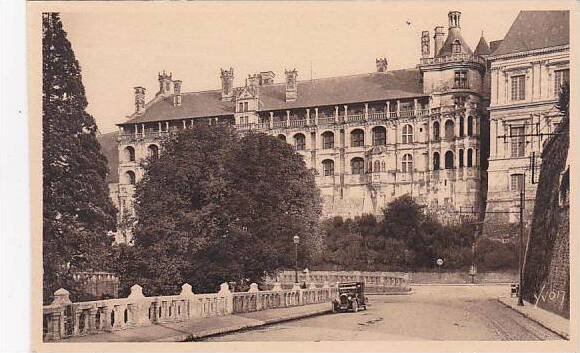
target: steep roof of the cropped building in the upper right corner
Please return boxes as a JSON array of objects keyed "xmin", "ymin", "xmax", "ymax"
[{"xmin": 493, "ymin": 11, "xmax": 570, "ymax": 56}]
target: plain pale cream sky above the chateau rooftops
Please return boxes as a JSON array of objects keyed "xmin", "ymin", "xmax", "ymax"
[{"xmin": 61, "ymin": 1, "xmax": 526, "ymax": 133}]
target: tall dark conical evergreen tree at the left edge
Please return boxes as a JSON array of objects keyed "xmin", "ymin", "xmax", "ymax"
[{"xmin": 42, "ymin": 13, "xmax": 116, "ymax": 301}]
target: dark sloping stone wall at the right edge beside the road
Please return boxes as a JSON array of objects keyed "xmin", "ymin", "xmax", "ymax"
[{"xmin": 522, "ymin": 119, "xmax": 570, "ymax": 318}]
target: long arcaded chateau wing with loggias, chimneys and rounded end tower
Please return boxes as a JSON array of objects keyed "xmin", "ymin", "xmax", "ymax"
[{"xmin": 105, "ymin": 11, "xmax": 490, "ymax": 241}]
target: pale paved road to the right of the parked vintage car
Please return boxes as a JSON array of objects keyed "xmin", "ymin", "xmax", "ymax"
[{"xmin": 206, "ymin": 285, "xmax": 561, "ymax": 342}]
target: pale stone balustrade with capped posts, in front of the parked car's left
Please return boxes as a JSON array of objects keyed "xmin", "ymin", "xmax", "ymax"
[{"xmin": 43, "ymin": 283, "xmax": 338, "ymax": 341}]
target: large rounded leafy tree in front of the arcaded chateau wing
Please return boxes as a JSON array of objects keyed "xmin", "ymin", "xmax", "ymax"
[{"xmin": 126, "ymin": 124, "xmax": 321, "ymax": 294}]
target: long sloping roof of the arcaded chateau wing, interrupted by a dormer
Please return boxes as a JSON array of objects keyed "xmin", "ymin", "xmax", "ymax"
[{"xmin": 119, "ymin": 68, "xmax": 425, "ymax": 125}]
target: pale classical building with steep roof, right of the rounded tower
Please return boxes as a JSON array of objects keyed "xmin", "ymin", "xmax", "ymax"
[{"xmin": 484, "ymin": 11, "xmax": 570, "ymax": 239}]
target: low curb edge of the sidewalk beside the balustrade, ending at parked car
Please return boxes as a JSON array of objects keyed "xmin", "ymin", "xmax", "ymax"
[{"xmin": 167, "ymin": 308, "xmax": 332, "ymax": 342}]
